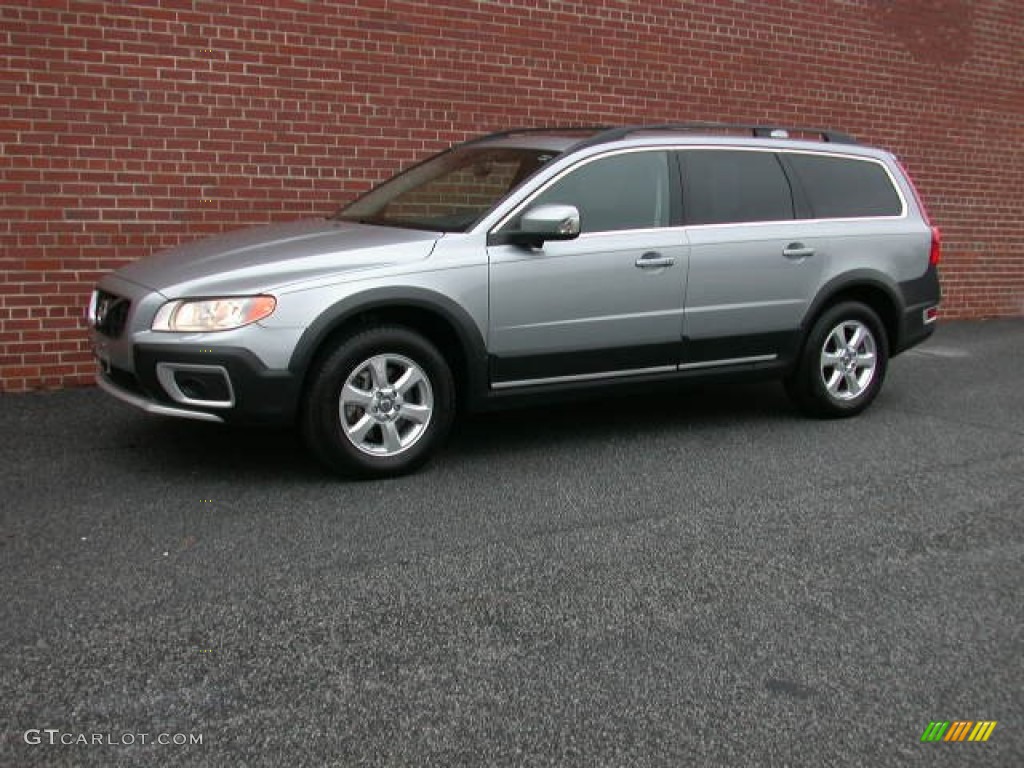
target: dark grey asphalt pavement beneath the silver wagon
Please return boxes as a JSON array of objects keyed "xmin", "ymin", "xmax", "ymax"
[{"xmin": 0, "ymin": 321, "xmax": 1024, "ymax": 767}]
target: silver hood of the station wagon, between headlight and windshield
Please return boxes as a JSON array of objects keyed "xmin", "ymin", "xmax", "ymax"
[{"xmin": 118, "ymin": 219, "xmax": 441, "ymax": 299}]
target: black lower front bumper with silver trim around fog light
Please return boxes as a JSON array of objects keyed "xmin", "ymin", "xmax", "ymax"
[{"xmin": 96, "ymin": 344, "xmax": 299, "ymax": 424}]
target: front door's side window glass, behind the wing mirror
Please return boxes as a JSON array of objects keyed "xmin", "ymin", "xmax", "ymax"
[{"xmin": 506, "ymin": 152, "xmax": 671, "ymax": 233}]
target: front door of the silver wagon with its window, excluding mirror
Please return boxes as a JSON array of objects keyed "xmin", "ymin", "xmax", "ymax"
[{"xmin": 487, "ymin": 151, "xmax": 688, "ymax": 388}]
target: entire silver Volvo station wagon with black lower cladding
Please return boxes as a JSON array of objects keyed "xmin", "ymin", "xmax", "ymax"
[{"xmin": 88, "ymin": 124, "xmax": 940, "ymax": 476}]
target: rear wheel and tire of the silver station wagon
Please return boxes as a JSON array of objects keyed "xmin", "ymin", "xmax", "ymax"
[{"xmin": 785, "ymin": 301, "xmax": 889, "ymax": 419}]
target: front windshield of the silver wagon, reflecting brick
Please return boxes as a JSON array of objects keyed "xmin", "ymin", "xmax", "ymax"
[{"xmin": 333, "ymin": 145, "xmax": 558, "ymax": 232}]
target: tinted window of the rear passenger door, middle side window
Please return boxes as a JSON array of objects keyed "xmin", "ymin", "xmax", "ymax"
[{"xmin": 681, "ymin": 150, "xmax": 794, "ymax": 224}]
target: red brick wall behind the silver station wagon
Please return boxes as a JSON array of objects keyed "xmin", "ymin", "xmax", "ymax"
[{"xmin": 0, "ymin": 0, "xmax": 1024, "ymax": 390}]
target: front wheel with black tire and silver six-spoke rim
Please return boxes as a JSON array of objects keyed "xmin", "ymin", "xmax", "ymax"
[{"xmin": 302, "ymin": 326, "xmax": 455, "ymax": 477}]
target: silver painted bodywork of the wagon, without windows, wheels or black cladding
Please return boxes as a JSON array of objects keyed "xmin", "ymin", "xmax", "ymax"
[{"xmin": 92, "ymin": 132, "xmax": 931, "ymax": 410}]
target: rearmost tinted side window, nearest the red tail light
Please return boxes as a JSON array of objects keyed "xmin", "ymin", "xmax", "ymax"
[{"xmin": 785, "ymin": 153, "xmax": 903, "ymax": 219}]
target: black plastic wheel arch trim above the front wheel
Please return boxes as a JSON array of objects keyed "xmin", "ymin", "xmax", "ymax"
[{"xmin": 288, "ymin": 288, "xmax": 487, "ymax": 408}]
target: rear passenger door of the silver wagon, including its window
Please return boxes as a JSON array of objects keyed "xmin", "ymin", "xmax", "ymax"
[{"xmin": 678, "ymin": 147, "xmax": 828, "ymax": 369}]
